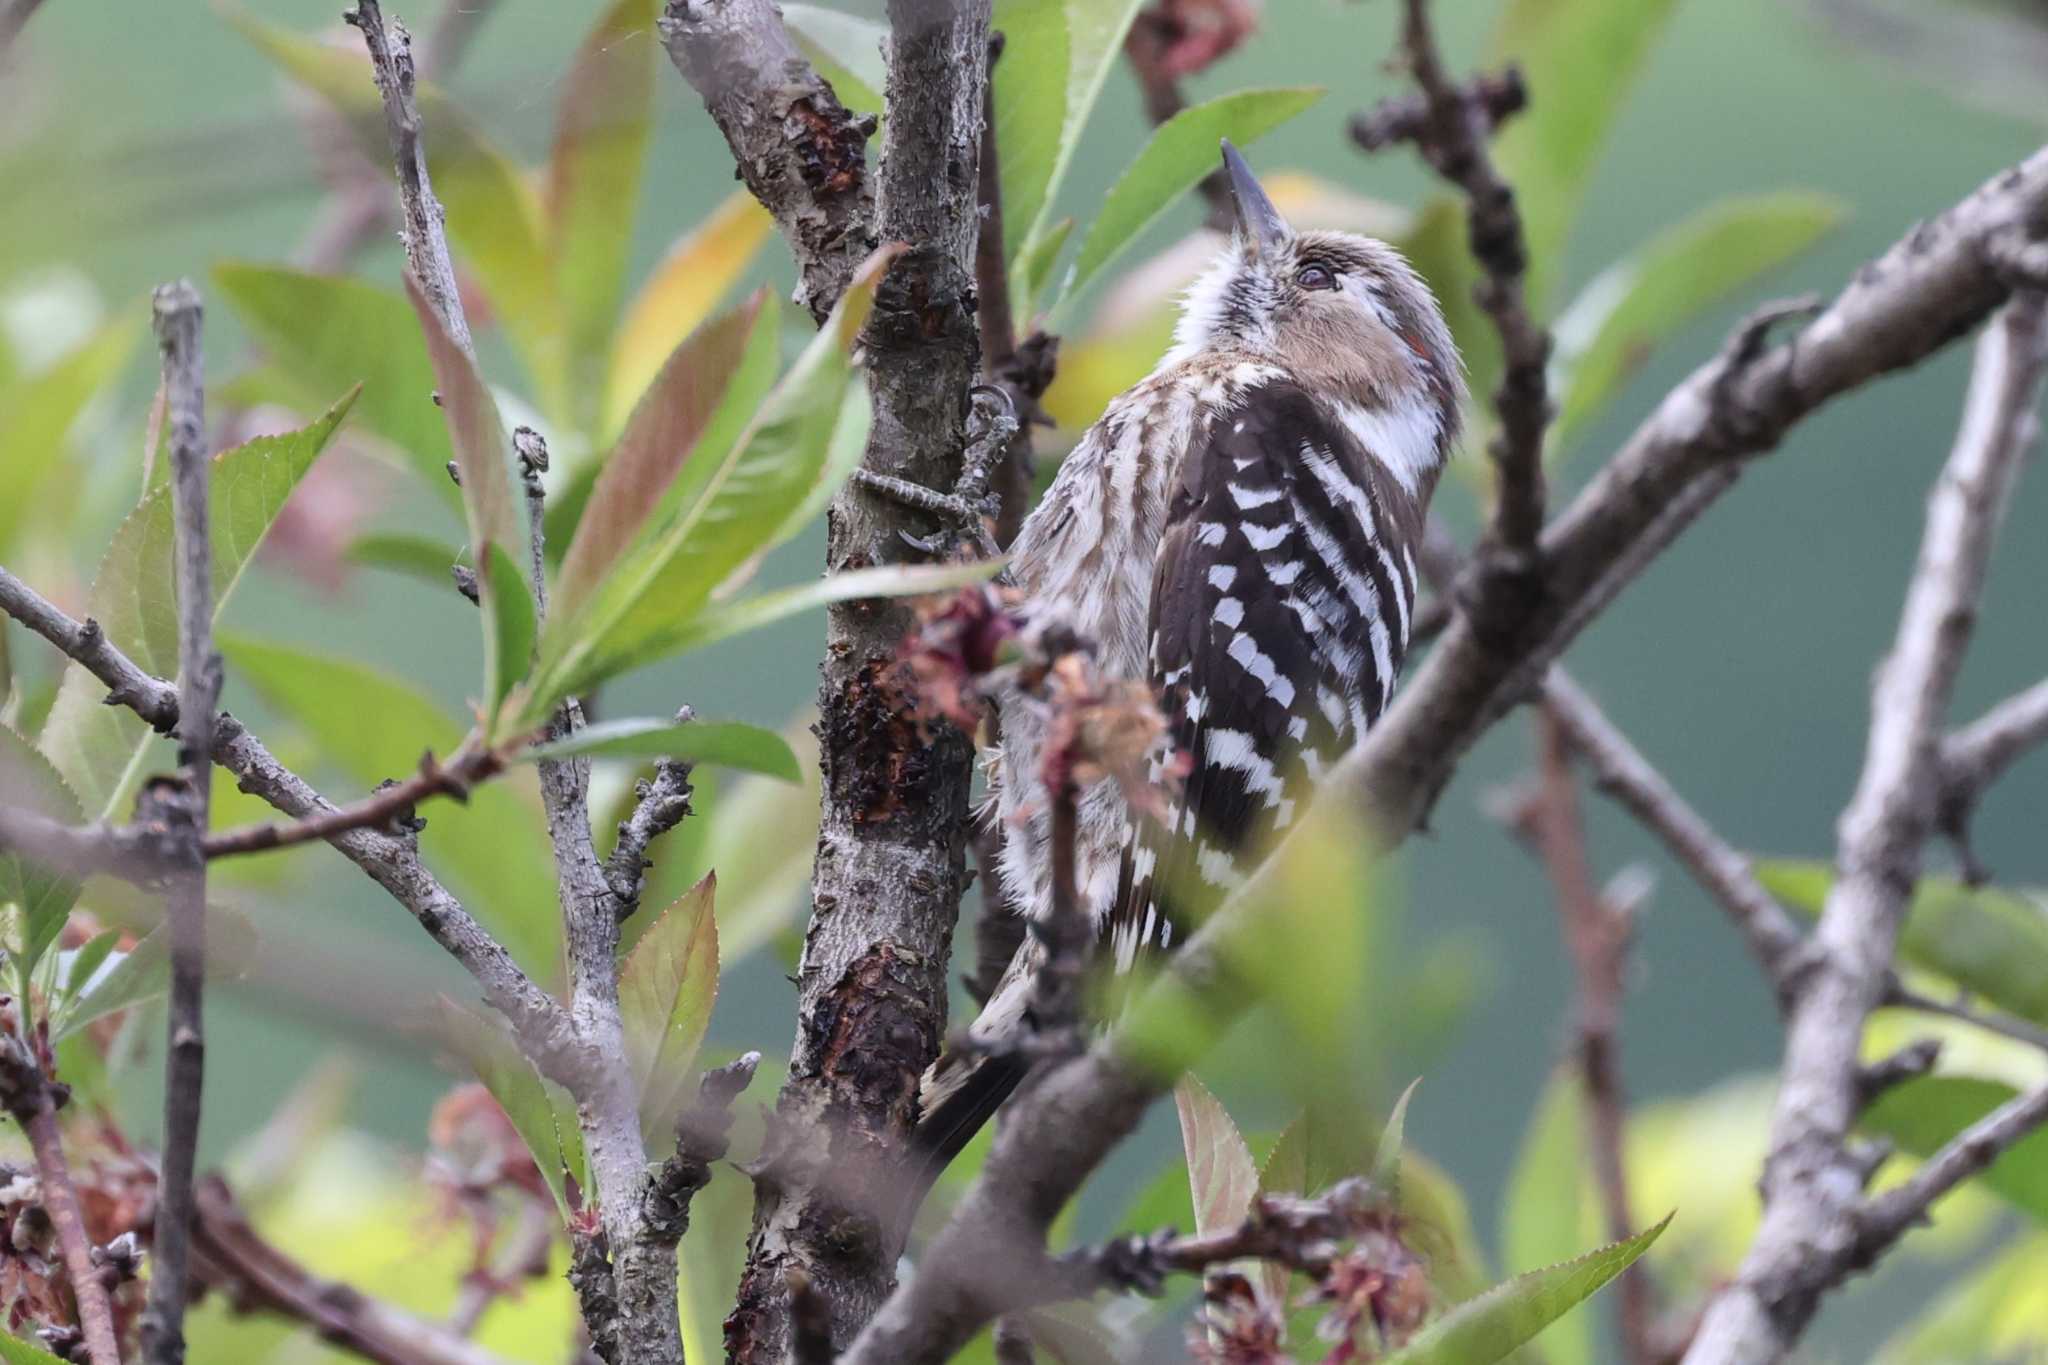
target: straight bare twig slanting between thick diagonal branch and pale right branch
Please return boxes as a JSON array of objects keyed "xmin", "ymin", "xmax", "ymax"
[{"xmin": 1544, "ymin": 667, "xmax": 1804, "ymax": 999}]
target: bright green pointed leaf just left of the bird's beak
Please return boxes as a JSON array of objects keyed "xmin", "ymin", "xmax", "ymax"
[{"xmin": 1059, "ymin": 86, "xmax": 1323, "ymax": 299}]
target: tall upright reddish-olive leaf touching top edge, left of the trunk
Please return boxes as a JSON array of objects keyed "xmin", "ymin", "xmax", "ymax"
[{"xmin": 547, "ymin": 0, "xmax": 653, "ymax": 436}]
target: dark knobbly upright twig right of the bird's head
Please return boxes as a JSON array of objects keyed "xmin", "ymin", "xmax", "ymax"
[{"xmin": 1352, "ymin": 0, "xmax": 1550, "ymax": 577}]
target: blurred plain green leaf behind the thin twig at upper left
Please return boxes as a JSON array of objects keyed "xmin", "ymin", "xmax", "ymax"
[{"xmin": 213, "ymin": 262, "xmax": 461, "ymax": 508}]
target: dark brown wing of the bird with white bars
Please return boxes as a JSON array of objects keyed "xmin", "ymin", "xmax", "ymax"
[{"xmin": 1108, "ymin": 385, "xmax": 1415, "ymax": 968}]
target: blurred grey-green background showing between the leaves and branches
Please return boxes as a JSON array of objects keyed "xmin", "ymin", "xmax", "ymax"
[{"xmin": 0, "ymin": 0, "xmax": 2048, "ymax": 1359}]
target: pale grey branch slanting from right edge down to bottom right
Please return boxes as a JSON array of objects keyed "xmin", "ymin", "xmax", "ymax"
[{"xmin": 1686, "ymin": 295, "xmax": 2048, "ymax": 1365}]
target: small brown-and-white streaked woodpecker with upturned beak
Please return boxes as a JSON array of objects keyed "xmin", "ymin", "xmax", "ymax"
[{"xmin": 918, "ymin": 141, "xmax": 1466, "ymax": 1166}]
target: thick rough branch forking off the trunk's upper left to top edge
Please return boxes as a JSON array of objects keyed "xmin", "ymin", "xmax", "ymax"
[{"xmin": 659, "ymin": 0, "xmax": 876, "ymax": 321}]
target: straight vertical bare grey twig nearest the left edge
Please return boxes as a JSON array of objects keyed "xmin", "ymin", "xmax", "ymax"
[{"xmin": 141, "ymin": 282, "xmax": 221, "ymax": 1365}]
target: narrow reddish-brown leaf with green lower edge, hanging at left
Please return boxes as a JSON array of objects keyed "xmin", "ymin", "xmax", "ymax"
[{"xmin": 406, "ymin": 274, "xmax": 535, "ymax": 739}]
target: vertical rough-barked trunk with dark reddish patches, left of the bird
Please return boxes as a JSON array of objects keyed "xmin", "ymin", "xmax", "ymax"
[{"xmin": 725, "ymin": 0, "xmax": 989, "ymax": 1365}]
